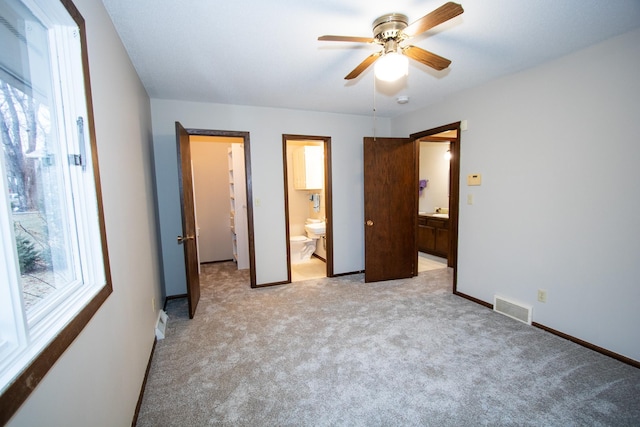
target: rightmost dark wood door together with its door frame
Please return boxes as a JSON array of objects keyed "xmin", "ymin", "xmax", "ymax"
[{"xmin": 364, "ymin": 122, "xmax": 460, "ymax": 292}]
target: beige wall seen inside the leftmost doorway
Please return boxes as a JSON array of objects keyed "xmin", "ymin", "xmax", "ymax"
[{"xmin": 191, "ymin": 141, "xmax": 233, "ymax": 262}]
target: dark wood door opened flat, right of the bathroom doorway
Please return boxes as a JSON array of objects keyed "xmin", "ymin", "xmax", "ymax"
[{"xmin": 364, "ymin": 138, "xmax": 418, "ymax": 282}]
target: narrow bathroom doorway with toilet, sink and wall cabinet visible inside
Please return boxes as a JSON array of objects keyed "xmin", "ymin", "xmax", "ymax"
[{"xmin": 282, "ymin": 135, "xmax": 333, "ymax": 283}]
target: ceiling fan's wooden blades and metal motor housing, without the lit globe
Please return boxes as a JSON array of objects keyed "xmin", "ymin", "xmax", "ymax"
[{"xmin": 318, "ymin": 2, "xmax": 464, "ymax": 80}]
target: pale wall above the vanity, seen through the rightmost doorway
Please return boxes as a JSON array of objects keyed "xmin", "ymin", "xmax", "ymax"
[{"xmin": 418, "ymin": 141, "xmax": 449, "ymax": 212}]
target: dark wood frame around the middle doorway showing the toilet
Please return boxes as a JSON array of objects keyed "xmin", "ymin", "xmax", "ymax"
[{"xmin": 282, "ymin": 134, "xmax": 335, "ymax": 283}]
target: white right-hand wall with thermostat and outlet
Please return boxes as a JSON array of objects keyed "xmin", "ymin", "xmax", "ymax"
[{"xmin": 391, "ymin": 31, "xmax": 640, "ymax": 360}]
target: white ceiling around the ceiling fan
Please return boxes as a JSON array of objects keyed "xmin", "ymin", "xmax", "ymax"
[{"xmin": 102, "ymin": 0, "xmax": 640, "ymax": 117}]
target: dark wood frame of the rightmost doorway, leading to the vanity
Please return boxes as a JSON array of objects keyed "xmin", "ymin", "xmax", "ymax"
[{"xmin": 410, "ymin": 122, "xmax": 460, "ymax": 294}]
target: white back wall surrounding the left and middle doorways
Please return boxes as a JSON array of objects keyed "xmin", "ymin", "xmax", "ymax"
[{"xmin": 151, "ymin": 99, "xmax": 389, "ymax": 295}]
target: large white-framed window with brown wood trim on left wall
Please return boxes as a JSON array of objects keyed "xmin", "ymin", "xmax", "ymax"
[{"xmin": 0, "ymin": 0, "xmax": 111, "ymax": 424}]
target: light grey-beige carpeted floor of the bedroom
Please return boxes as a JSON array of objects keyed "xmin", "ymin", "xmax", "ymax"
[{"xmin": 137, "ymin": 263, "xmax": 640, "ymax": 426}]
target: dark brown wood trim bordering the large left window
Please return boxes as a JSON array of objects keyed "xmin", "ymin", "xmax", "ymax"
[{"xmin": 0, "ymin": 0, "xmax": 113, "ymax": 425}]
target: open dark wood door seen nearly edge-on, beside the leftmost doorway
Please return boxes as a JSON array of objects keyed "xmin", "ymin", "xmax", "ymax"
[{"xmin": 176, "ymin": 122, "xmax": 200, "ymax": 319}]
